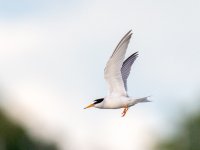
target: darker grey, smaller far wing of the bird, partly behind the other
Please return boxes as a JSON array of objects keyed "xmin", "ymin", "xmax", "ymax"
[{"xmin": 121, "ymin": 52, "xmax": 138, "ymax": 91}]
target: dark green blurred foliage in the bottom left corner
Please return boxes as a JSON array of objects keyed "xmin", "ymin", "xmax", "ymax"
[{"xmin": 0, "ymin": 110, "xmax": 56, "ymax": 150}]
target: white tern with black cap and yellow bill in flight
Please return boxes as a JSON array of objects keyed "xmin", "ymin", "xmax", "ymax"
[{"xmin": 84, "ymin": 30, "xmax": 150, "ymax": 117}]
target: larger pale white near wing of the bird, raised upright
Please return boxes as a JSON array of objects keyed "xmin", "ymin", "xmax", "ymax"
[{"xmin": 104, "ymin": 30, "xmax": 132, "ymax": 95}]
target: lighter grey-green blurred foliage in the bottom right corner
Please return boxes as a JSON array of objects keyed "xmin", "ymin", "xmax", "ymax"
[{"xmin": 156, "ymin": 106, "xmax": 200, "ymax": 150}]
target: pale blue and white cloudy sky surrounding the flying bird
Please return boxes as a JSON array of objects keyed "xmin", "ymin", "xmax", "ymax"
[{"xmin": 0, "ymin": 0, "xmax": 200, "ymax": 150}]
